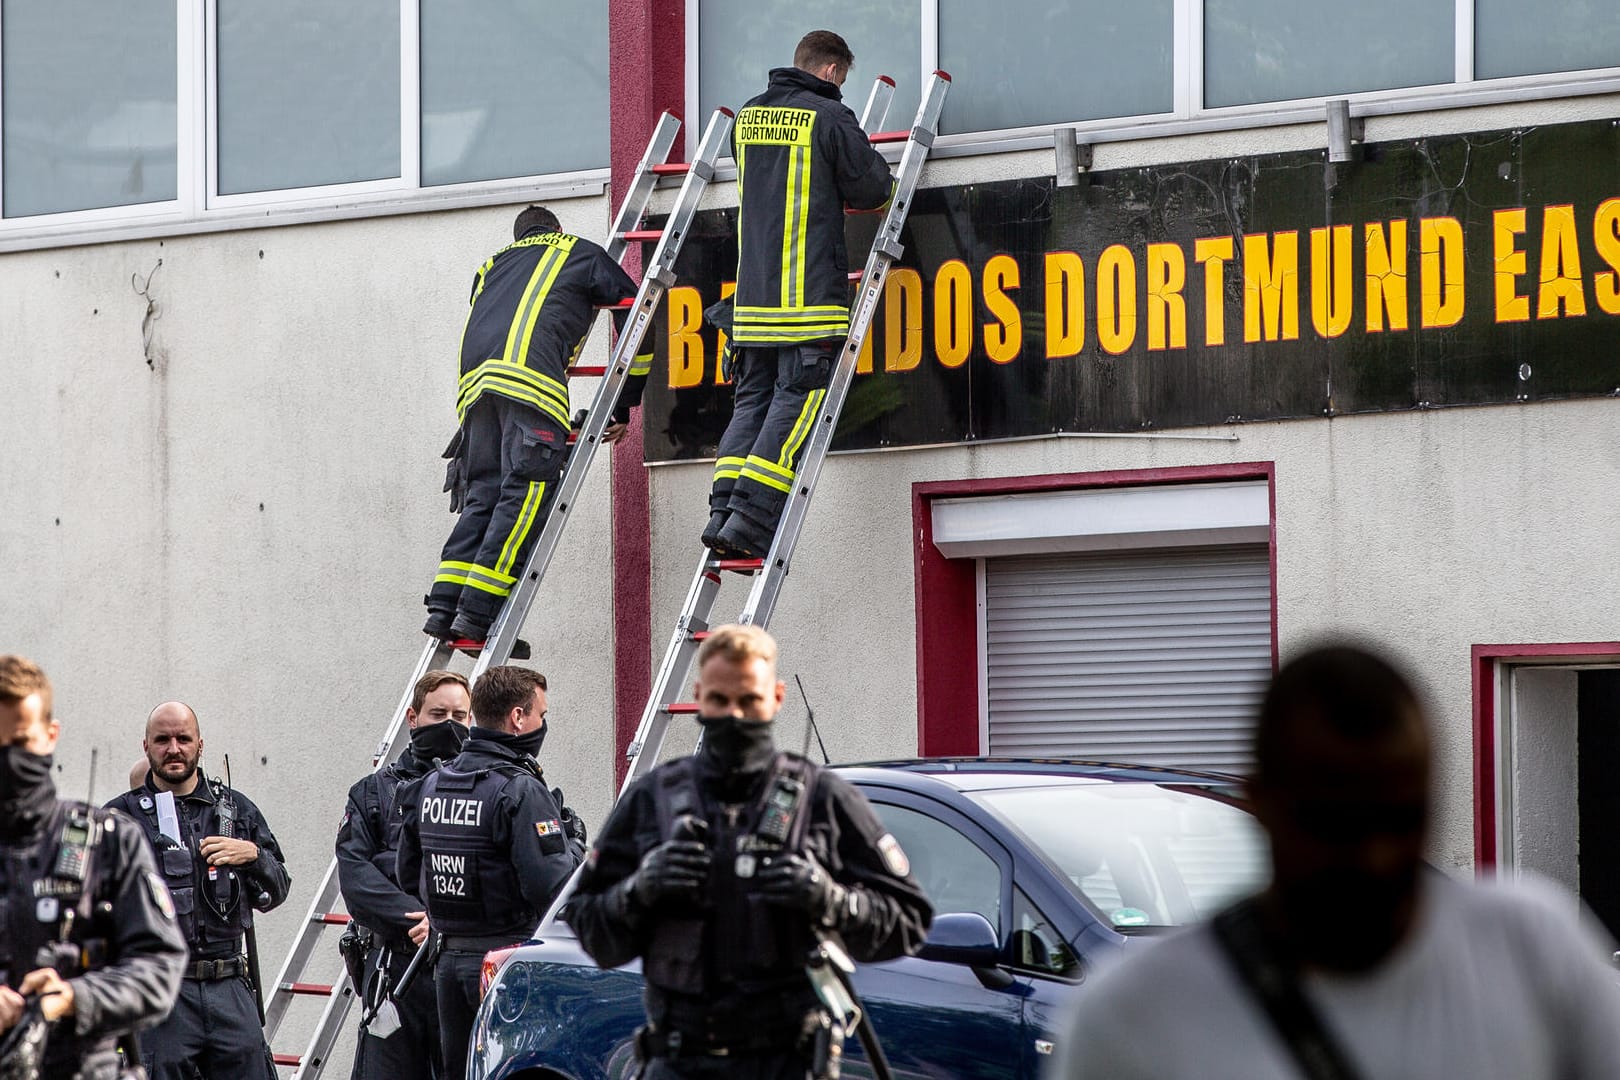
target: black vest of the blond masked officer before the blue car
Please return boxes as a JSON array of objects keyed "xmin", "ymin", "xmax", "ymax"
[{"xmin": 643, "ymin": 753, "xmax": 820, "ymax": 996}]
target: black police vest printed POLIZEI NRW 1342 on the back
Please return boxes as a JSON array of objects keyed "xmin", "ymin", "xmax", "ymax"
[{"xmin": 416, "ymin": 763, "xmax": 539, "ymax": 936}]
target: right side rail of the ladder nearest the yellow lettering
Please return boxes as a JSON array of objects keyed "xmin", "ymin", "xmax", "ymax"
[{"xmin": 737, "ymin": 71, "xmax": 949, "ymax": 627}]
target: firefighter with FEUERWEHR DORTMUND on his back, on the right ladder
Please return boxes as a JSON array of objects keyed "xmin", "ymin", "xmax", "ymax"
[{"xmin": 703, "ymin": 31, "xmax": 894, "ymax": 557}]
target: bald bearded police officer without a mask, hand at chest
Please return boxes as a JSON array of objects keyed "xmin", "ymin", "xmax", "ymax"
[{"xmin": 107, "ymin": 701, "xmax": 292, "ymax": 1080}]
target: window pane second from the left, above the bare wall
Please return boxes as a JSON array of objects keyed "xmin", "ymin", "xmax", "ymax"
[{"xmin": 219, "ymin": 0, "xmax": 400, "ymax": 194}]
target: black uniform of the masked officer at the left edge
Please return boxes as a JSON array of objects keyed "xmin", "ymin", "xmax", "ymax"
[{"xmin": 0, "ymin": 746, "xmax": 186, "ymax": 1080}]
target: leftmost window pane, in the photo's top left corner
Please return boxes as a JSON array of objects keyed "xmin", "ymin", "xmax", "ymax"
[{"xmin": 0, "ymin": 0, "xmax": 180, "ymax": 217}]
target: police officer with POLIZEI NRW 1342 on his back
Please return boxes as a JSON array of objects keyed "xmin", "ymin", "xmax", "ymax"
[{"xmin": 399, "ymin": 667, "xmax": 585, "ymax": 1080}]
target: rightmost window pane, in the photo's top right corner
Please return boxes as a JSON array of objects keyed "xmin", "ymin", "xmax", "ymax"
[{"xmin": 1474, "ymin": 0, "xmax": 1620, "ymax": 79}]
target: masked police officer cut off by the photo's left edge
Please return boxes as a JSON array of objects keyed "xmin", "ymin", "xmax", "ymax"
[{"xmin": 0, "ymin": 656, "xmax": 186, "ymax": 1080}]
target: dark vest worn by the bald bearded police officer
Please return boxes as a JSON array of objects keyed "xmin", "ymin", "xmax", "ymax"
[{"xmin": 122, "ymin": 777, "xmax": 253, "ymax": 955}]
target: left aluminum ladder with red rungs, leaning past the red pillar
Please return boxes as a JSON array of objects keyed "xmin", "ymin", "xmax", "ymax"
[{"xmin": 264, "ymin": 110, "xmax": 731, "ymax": 1080}]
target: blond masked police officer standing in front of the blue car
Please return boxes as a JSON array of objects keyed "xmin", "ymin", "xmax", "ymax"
[{"xmin": 567, "ymin": 627, "xmax": 933, "ymax": 1080}]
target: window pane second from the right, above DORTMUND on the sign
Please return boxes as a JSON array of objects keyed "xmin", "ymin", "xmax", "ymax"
[{"xmin": 1204, "ymin": 0, "xmax": 1456, "ymax": 108}]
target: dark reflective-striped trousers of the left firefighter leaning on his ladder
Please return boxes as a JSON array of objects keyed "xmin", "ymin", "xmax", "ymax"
[{"xmin": 428, "ymin": 393, "xmax": 569, "ymax": 627}]
